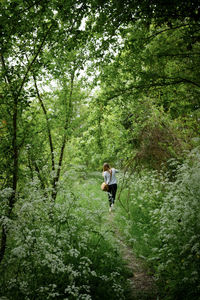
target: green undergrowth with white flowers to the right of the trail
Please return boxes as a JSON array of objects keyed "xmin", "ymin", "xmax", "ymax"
[{"xmin": 115, "ymin": 149, "xmax": 200, "ymax": 299}]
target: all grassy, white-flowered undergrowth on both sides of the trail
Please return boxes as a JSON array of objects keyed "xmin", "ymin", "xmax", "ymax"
[{"xmin": 0, "ymin": 149, "xmax": 200, "ymax": 300}]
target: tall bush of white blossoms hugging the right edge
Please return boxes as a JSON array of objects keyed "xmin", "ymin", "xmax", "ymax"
[{"xmin": 154, "ymin": 151, "xmax": 200, "ymax": 299}]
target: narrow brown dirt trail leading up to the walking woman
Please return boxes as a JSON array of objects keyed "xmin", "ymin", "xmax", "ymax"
[{"xmin": 109, "ymin": 212, "xmax": 159, "ymax": 300}]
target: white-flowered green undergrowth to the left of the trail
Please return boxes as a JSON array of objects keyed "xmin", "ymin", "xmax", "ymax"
[{"xmin": 0, "ymin": 173, "xmax": 130, "ymax": 299}]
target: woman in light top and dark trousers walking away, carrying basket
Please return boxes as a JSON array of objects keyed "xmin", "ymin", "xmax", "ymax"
[{"xmin": 103, "ymin": 163, "xmax": 118, "ymax": 212}]
